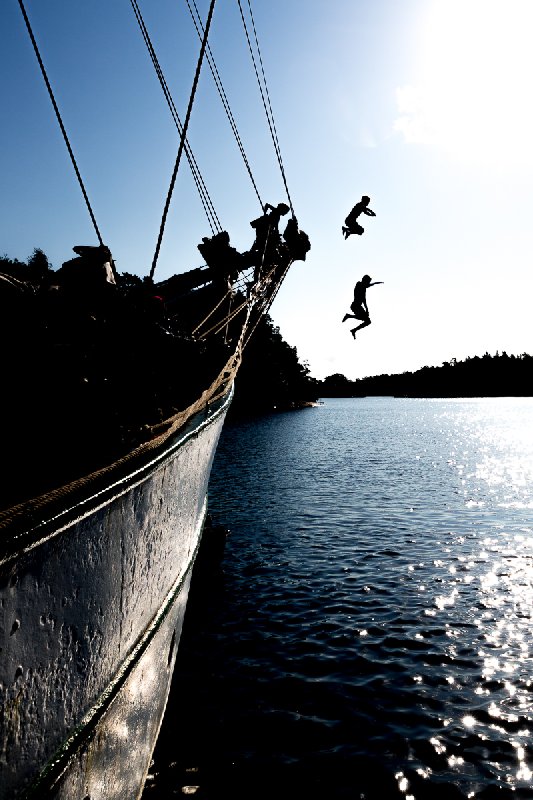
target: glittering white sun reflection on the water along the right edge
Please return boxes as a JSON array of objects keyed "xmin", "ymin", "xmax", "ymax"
[{"xmin": 422, "ymin": 402, "xmax": 533, "ymax": 797}]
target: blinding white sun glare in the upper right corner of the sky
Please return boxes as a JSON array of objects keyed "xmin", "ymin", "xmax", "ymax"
[{"xmin": 394, "ymin": 0, "xmax": 533, "ymax": 166}]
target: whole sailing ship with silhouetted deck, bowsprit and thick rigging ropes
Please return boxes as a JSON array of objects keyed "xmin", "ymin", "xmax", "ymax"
[{"xmin": 0, "ymin": 0, "xmax": 310, "ymax": 800}]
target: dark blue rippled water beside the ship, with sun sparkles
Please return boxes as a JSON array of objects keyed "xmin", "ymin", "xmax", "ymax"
[{"xmin": 145, "ymin": 398, "xmax": 533, "ymax": 800}]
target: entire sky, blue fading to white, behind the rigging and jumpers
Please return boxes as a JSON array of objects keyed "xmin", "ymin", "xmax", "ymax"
[{"xmin": 0, "ymin": 0, "xmax": 533, "ymax": 379}]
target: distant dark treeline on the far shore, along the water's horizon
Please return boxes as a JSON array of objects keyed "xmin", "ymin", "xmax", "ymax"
[{"xmin": 320, "ymin": 352, "xmax": 533, "ymax": 397}]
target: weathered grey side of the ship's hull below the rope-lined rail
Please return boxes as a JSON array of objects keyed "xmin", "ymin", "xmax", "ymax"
[{"xmin": 0, "ymin": 382, "xmax": 231, "ymax": 800}]
